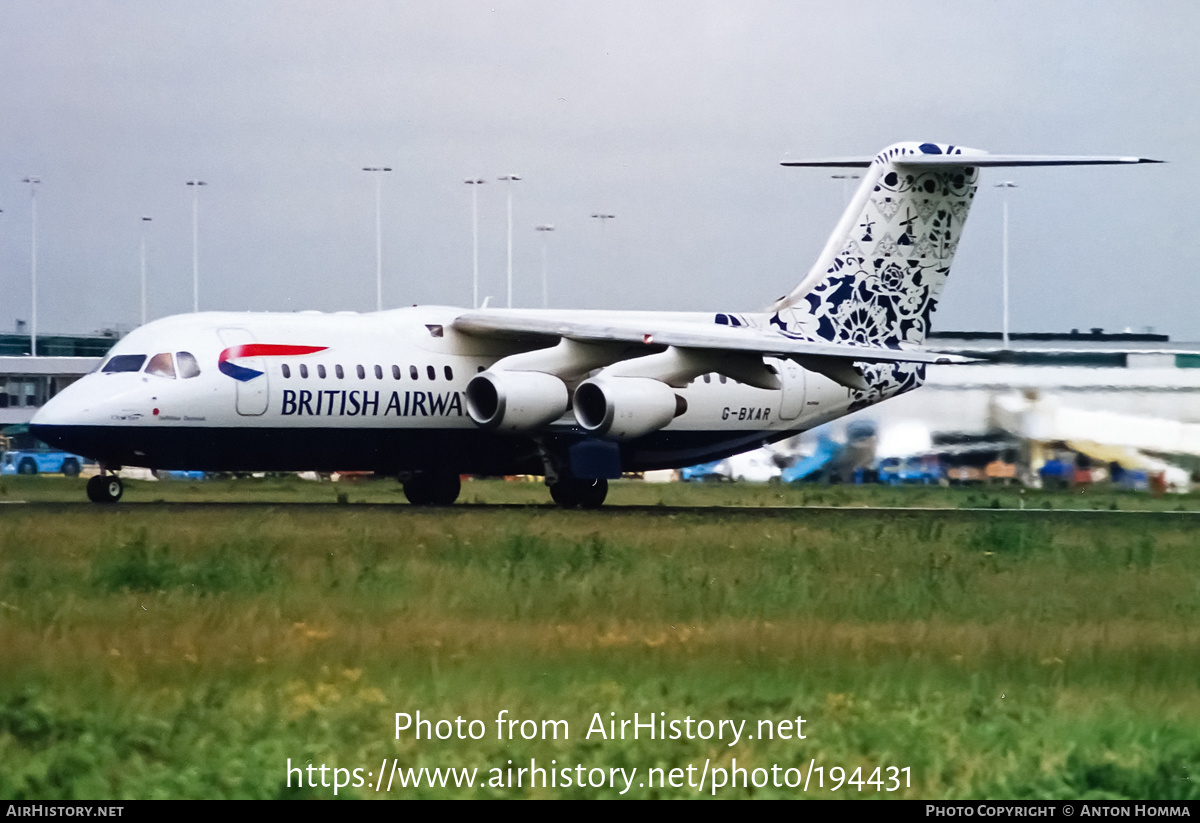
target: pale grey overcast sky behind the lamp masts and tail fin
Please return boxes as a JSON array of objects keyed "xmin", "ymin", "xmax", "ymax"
[{"xmin": 0, "ymin": 0, "xmax": 1200, "ymax": 340}]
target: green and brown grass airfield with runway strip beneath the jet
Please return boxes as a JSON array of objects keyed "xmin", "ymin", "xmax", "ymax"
[{"xmin": 0, "ymin": 477, "xmax": 1200, "ymax": 798}]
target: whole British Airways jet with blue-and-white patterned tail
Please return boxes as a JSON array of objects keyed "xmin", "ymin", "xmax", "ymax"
[{"xmin": 30, "ymin": 143, "xmax": 1158, "ymax": 509}]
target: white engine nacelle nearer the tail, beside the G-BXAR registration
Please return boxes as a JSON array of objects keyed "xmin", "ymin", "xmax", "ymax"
[{"xmin": 571, "ymin": 377, "xmax": 688, "ymax": 440}]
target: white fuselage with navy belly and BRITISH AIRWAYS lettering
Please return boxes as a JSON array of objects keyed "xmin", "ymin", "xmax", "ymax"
[{"xmin": 32, "ymin": 307, "xmax": 873, "ymax": 474}]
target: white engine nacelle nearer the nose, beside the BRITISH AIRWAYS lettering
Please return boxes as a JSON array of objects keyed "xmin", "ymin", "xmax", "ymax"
[{"xmin": 467, "ymin": 372, "xmax": 570, "ymax": 432}]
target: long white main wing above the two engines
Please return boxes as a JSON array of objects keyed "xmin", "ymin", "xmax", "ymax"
[{"xmin": 452, "ymin": 311, "xmax": 971, "ymax": 364}]
